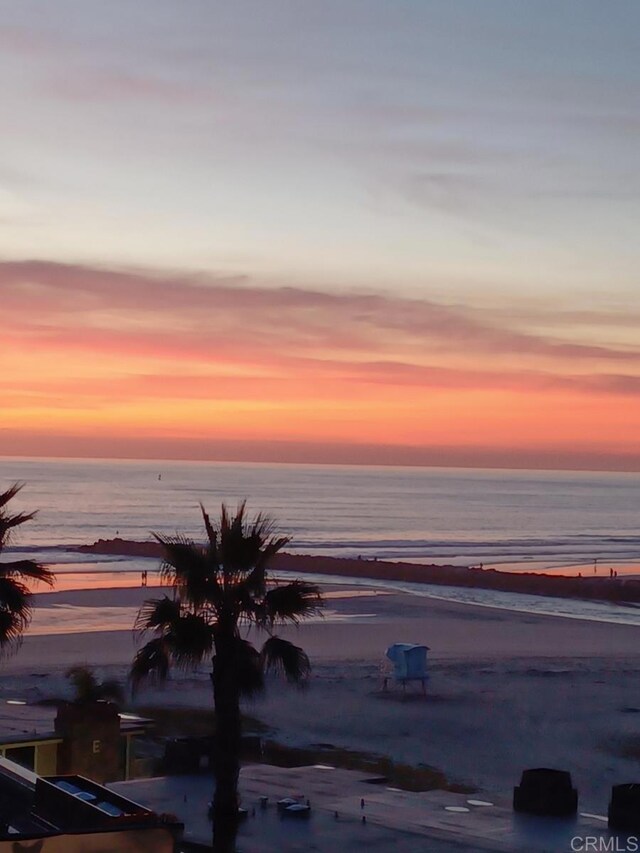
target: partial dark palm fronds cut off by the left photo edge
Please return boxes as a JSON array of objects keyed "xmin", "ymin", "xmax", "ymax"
[{"xmin": 0, "ymin": 483, "xmax": 54, "ymax": 653}]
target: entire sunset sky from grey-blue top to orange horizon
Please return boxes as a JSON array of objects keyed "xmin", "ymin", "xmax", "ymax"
[{"xmin": 0, "ymin": 0, "xmax": 640, "ymax": 471}]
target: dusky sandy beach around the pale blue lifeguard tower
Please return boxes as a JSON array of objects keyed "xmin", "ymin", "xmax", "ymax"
[{"xmin": 0, "ymin": 586, "xmax": 640, "ymax": 812}]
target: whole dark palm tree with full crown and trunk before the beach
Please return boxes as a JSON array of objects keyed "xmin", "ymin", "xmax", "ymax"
[{"xmin": 131, "ymin": 502, "xmax": 322, "ymax": 853}]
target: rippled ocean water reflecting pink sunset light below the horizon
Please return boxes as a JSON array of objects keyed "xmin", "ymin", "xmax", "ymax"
[{"xmin": 0, "ymin": 459, "xmax": 640, "ymax": 624}]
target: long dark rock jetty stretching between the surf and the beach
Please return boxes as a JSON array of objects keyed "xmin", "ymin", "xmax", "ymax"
[{"xmin": 75, "ymin": 537, "xmax": 640, "ymax": 604}]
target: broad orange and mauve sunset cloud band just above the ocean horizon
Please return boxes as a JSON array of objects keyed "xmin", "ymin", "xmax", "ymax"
[{"xmin": 0, "ymin": 262, "xmax": 640, "ymax": 467}]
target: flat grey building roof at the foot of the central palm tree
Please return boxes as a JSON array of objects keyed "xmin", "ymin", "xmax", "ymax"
[{"xmin": 108, "ymin": 764, "xmax": 624, "ymax": 853}]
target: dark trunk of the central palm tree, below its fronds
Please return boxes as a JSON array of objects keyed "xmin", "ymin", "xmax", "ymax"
[{"xmin": 211, "ymin": 638, "xmax": 241, "ymax": 853}]
